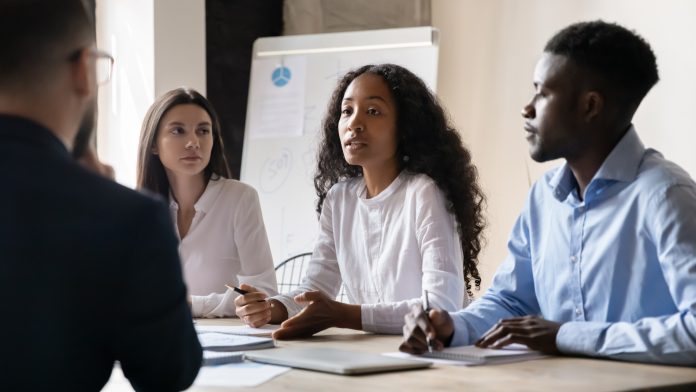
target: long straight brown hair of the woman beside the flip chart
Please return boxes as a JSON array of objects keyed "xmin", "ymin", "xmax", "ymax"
[{"xmin": 137, "ymin": 87, "xmax": 230, "ymax": 198}]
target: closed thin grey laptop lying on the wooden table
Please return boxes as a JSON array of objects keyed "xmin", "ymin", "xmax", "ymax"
[{"xmin": 244, "ymin": 347, "xmax": 432, "ymax": 375}]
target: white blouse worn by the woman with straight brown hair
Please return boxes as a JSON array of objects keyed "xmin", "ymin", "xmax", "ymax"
[{"xmin": 170, "ymin": 178, "xmax": 278, "ymax": 317}]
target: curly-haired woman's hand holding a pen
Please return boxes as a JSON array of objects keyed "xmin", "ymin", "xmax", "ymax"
[{"xmin": 234, "ymin": 283, "xmax": 288, "ymax": 328}]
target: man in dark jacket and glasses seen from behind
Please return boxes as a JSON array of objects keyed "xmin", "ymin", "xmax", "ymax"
[{"xmin": 0, "ymin": 0, "xmax": 201, "ymax": 391}]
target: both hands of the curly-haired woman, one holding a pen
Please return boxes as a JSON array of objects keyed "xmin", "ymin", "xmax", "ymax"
[{"xmin": 234, "ymin": 284, "xmax": 361, "ymax": 339}]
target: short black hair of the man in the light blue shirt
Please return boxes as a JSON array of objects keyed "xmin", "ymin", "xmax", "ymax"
[{"xmin": 544, "ymin": 20, "xmax": 660, "ymax": 107}]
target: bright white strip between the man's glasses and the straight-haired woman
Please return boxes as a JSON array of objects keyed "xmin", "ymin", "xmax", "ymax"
[{"xmin": 97, "ymin": 0, "xmax": 155, "ymax": 186}]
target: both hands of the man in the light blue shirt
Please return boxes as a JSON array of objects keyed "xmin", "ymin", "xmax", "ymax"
[{"xmin": 399, "ymin": 306, "xmax": 561, "ymax": 354}]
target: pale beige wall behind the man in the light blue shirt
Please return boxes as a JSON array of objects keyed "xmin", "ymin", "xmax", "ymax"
[{"xmin": 432, "ymin": 0, "xmax": 696, "ymax": 294}]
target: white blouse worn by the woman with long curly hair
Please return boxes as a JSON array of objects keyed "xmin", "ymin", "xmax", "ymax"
[{"xmin": 275, "ymin": 172, "xmax": 468, "ymax": 334}]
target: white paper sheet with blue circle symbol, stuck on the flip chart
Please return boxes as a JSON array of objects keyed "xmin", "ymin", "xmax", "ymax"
[{"xmin": 247, "ymin": 56, "xmax": 307, "ymax": 139}]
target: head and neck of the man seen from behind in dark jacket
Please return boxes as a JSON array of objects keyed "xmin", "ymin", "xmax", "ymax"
[{"xmin": 0, "ymin": 0, "xmax": 96, "ymax": 148}]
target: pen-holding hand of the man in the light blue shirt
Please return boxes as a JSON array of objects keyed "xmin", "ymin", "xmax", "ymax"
[{"xmin": 399, "ymin": 305, "xmax": 454, "ymax": 354}]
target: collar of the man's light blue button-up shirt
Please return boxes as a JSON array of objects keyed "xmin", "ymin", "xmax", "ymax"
[{"xmin": 548, "ymin": 125, "xmax": 645, "ymax": 201}]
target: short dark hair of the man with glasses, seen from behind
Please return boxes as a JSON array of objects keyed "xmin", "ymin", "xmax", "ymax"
[{"xmin": 0, "ymin": 0, "xmax": 95, "ymax": 87}]
